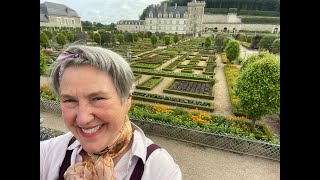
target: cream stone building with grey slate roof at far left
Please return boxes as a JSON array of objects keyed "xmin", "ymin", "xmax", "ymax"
[{"xmin": 40, "ymin": 2, "xmax": 82, "ymax": 30}]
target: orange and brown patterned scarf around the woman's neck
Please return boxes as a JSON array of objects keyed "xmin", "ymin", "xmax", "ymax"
[{"xmin": 64, "ymin": 115, "xmax": 132, "ymax": 180}]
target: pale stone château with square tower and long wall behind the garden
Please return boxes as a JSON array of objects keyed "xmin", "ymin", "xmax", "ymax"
[{"xmin": 116, "ymin": 0, "xmax": 280, "ymax": 36}]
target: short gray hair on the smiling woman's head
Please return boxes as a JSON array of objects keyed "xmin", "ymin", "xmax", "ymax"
[{"xmin": 51, "ymin": 45, "xmax": 134, "ymax": 102}]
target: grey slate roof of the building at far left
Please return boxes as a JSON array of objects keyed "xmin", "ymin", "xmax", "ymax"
[{"xmin": 40, "ymin": 1, "xmax": 80, "ymax": 17}]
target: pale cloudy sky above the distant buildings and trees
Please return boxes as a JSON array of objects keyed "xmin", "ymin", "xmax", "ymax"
[{"xmin": 40, "ymin": 0, "xmax": 163, "ymax": 24}]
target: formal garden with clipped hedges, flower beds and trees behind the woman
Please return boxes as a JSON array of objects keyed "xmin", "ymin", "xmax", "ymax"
[{"xmin": 40, "ymin": 28, "xmax": 280, "ymax": 160}]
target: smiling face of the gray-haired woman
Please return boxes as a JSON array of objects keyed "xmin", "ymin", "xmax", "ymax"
[{"xmin": 60, "ymin": 65, "xmax": 131, "ymax": 153}]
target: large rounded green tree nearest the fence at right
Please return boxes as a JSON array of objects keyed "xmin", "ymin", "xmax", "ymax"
[{"xmin": 234, "ymin": 54, "xmax": 280, "ymax": 132}]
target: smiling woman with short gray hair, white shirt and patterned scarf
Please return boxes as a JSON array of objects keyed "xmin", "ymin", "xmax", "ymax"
[{"xmin": 40, "ymin": 45, "xmax": 182, "ymax": 180}]
